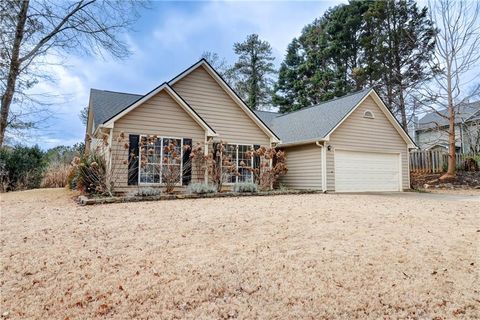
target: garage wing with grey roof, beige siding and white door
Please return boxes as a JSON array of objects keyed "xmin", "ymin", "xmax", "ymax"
[{"xmin": 257, "ymin": 89, "xmax": 415, "ymax": 192}]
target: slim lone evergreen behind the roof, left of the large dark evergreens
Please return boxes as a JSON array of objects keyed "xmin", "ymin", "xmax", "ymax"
[{"xmin": 233, "ymin": 34, "xmax": 275, "ymax": 110}]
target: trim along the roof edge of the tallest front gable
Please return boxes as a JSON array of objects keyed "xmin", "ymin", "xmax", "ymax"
[{"xmin": 168, "ymin": 58, "xmax": 280, "ymax": 142}]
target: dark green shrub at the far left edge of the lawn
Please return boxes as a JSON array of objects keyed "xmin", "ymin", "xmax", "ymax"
[{"xmin": 0, "ymin": 146, "xmax": 47, "ymax": 191}]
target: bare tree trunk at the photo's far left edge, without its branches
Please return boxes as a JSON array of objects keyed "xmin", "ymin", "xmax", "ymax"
[{"xmin": 0, "ymin": 0, "xmax": 29, "ymax": 146}]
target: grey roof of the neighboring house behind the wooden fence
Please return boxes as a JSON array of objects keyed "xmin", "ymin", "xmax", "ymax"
[{"xmin": 416, "ymin": 101, "xmax": 480, "ymax": 130}]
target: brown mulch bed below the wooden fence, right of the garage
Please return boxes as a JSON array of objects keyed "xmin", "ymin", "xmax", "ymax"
[{"xmin": 410, "ymin": 171, "xmax": 480, "ymax": 189}]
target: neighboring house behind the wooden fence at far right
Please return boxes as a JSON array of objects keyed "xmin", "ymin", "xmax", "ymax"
[{"xmin": 414, "ymin": 101, "xmax": 480, "ymax": 153}]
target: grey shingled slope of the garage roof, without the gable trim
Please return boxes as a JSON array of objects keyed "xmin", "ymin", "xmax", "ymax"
[{"xmin": 270, "ymin": 89, "xmax": 371, "ymax": 143}]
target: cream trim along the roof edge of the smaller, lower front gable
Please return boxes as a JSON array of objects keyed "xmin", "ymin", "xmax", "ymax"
[{"xmin": 103, "ymin": 82, "xmax": 216, "ymax": 136}]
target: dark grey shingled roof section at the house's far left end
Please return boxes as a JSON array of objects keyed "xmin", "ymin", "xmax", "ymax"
[{"xmin": 90, "ymin": 89, "xmax": 143, "ymax": 128}]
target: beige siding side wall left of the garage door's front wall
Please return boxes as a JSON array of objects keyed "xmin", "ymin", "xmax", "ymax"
[{"xmin": 280, "ymin": 143, "xmax": 322, "ymax": 190}]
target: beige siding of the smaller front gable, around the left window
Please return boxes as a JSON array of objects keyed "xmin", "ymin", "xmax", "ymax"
[{"xmin": 112, "ymin": 91, "xmax": 205, "ymax": 187}]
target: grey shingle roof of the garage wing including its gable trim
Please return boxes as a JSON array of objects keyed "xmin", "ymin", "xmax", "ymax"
[{"xmin": 256, "ymin": 88, "xmax": 415, "ymax": 147}]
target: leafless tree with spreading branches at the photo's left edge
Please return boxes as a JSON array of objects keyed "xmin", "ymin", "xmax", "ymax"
[{"xmin": 0, "ymin": 0, "xmax": 143, "ymax": 145}]
